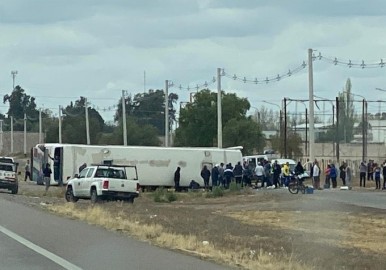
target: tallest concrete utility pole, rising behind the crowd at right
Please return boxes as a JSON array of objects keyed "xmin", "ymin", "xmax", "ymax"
[{"xmin": 308, "ymin": 49, "xmax": 315, "ymax": 162}]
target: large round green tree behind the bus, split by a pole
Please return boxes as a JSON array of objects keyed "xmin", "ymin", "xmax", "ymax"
[{"xmin": 175, "ymin": 89, "xmax": 262, "ymax": 152}]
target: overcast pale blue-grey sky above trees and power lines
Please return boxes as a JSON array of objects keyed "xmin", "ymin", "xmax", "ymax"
[{"xmin": 0, "ymin": 0, "xmax": 386, "ymax": 121}]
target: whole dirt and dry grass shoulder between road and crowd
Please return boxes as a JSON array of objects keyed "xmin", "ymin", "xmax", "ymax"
[{"xmin": 1, "ymin": 181, "xmax": 386, "ymax": 269}]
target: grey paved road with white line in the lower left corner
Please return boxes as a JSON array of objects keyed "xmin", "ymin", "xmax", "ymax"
[{"xmin": 0, "ymin": 194, "xmax": 227, "ymax": 270}]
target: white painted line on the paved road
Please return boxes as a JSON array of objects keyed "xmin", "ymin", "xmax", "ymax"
[{"xmin": 0, "ymin": 225, "xmax": 82, "ymax": 270}]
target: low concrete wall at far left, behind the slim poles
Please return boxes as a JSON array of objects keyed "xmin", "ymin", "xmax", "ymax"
[{"xmin": 0, "ymin": 131, "xmax": 40, "ymax": 156}]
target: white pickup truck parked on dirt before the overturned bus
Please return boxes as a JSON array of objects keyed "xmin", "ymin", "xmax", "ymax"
[{"xmin": 65, "ymin": 165, "xmax": 140, "ymax": 203}]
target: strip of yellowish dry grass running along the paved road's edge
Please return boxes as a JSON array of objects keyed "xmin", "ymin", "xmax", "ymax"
[{"xmin": 48, "ymin": 202, "xmax": 311, "ymax": 270}]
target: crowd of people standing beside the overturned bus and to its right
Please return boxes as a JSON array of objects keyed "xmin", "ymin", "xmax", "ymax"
[{"xmin": 174, "ymin": 160, "xmax": 386, "ymax": 191}]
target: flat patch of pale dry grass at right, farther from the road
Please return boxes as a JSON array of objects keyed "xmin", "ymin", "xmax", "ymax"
[{"xmin": 229, "ymin": 211, "xmax": 386, "ymax": 254}]
